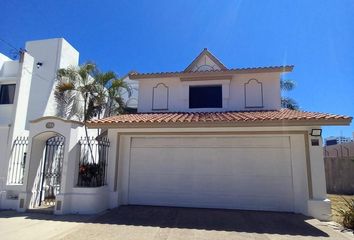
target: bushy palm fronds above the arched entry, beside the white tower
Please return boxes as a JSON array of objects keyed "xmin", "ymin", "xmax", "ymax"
[{"xmin": 54, "ymin": 63, "xmax": 131, "ymax": 123}]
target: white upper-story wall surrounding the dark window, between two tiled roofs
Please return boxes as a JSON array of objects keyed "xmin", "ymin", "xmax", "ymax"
[{"xmin": 138, "ymin": 73, "xmax": 280, "ymax": 112}]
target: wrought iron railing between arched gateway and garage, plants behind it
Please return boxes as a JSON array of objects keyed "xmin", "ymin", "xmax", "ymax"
[{"xmin": 77, "ymin": 137, "xmax": 109, "ymax": 187}]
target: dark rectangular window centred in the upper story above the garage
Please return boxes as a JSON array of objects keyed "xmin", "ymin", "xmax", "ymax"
[{"xmin": 189, "ymin": 86, "xmax": 222, "ymax": 108}]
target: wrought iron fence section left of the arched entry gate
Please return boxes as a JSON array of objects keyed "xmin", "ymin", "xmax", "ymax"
[{"xmin": 7, "ymin": 137, "xmax": 28, "ymax": 184}]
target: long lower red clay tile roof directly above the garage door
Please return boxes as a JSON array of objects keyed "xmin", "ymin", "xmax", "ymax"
[{"xmin": 89, "ymin": 109, "xmax": 352, "ymax": 126}]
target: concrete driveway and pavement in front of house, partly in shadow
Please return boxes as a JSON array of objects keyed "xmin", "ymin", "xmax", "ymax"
[{"xmin": 0, "ymin": 206, "xmax": 354, "ymax": 240}]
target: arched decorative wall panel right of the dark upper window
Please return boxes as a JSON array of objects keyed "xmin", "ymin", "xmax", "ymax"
[{"xmin": 244, "ymin": 79, "xmax": 263, "ymax": 108}]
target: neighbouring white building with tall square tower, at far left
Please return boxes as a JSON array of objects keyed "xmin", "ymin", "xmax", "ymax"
[{"xmin": 0, "ymin": 38, "xmax": 79, "ymax": 195}]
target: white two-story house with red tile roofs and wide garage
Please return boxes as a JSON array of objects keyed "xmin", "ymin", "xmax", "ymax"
[{"xmin": 90, "ymin": 49, "xmax": 351, "ymax": 219}]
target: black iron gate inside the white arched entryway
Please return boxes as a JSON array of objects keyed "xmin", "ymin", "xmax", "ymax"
[{"xmin": 39, "ymin": 136, "xmax": 64, "ymax": 206}]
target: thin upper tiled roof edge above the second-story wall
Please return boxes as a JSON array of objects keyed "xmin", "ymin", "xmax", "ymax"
[{"xmin": 129, "ymin": 65, "xmax": 294, "ymax": 79}]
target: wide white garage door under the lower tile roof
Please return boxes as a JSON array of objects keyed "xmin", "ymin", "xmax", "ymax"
[{"xmin": 128, "ymin": 136, "xmax": 294, "ymax": 211}]
